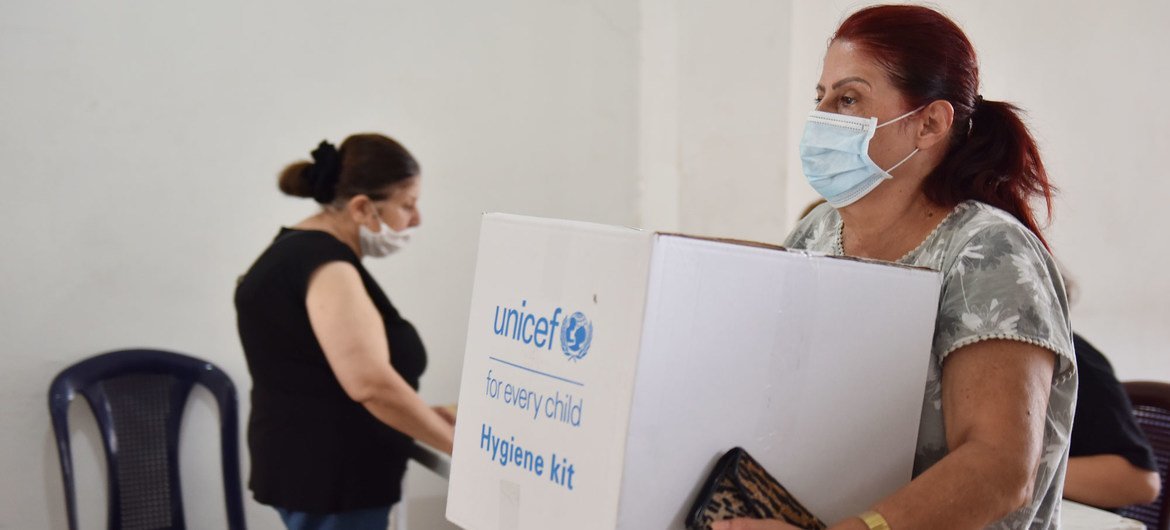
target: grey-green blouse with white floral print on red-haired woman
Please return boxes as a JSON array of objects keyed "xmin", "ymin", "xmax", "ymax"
[{"xmin": 785, "ymin": 201, "xmax": 1076, "ymax": 529}]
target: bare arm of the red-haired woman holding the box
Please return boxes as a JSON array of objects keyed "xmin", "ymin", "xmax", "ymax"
[{"xmin": 716, "ymin": 340, "xmax": 1055, "ymax": 530}]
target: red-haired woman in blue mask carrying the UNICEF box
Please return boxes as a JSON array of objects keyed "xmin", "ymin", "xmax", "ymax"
[{"xmin": 714, "ymin": 6, "xmax": 1076, "ymax": 530}]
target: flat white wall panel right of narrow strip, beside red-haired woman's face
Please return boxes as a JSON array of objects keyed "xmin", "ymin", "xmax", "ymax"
[{"xmin": 677, "ymin": 1, "xmax": 790, "ymax": 243}]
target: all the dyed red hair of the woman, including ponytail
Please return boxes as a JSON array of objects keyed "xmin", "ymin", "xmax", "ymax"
[{"xmin": 832, "ymin": 6, "xmax": 1054, "ymax": 247}]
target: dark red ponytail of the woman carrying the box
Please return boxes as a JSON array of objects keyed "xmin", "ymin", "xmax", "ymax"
[{"xmin": 923, "ymin": 97, "xmax": 1053, "ymax": 246}]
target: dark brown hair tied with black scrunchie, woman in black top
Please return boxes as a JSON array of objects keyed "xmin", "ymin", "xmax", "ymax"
[{"xmin": 277, "ymin": 133, "xmax": 419, "ymax": 205}]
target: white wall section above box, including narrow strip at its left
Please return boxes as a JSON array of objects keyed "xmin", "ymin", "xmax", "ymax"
[{"xmin": 639, "ymin": 0, "xmax": 791, "ymax": 243}]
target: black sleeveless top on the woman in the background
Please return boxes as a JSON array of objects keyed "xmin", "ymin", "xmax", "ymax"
[{"xmin": 235, "ymin": 228, "xmax": 427, "ymax": 514}]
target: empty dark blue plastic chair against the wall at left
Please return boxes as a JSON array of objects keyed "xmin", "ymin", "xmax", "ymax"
[{"xmin": 49, "ymin": 350, "xmax": 245, "ymax": 530}]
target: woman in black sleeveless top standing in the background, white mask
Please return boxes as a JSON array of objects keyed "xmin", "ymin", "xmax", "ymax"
[{"xmin": 235, "ymin": 135, "xmax": 454, "ymax": 530}]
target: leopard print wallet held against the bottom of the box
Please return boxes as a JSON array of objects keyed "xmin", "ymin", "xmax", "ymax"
[{"xmin": 687, "ymin": 447, "xmax": 825, "ymax": 530}]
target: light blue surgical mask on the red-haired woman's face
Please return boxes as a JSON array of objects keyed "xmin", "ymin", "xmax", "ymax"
[{"xmin": 800, "ymin": 106, "xmax": 922, "ymax": 208}]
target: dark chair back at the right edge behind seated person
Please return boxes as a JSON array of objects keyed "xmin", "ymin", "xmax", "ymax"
[{"xmin": 1119, "ymin": 381, "xmax": 1170, "ymax": 530}]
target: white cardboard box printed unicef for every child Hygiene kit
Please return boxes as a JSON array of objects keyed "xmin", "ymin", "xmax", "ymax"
[{"xmin": 447, "ymin": 214, "xmax": 940, "ymax": 530}]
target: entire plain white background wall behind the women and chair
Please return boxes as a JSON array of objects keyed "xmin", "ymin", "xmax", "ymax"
[{"xmin": 0, "ymin": 0, "xmax": 1170, "ymax": 530}]
